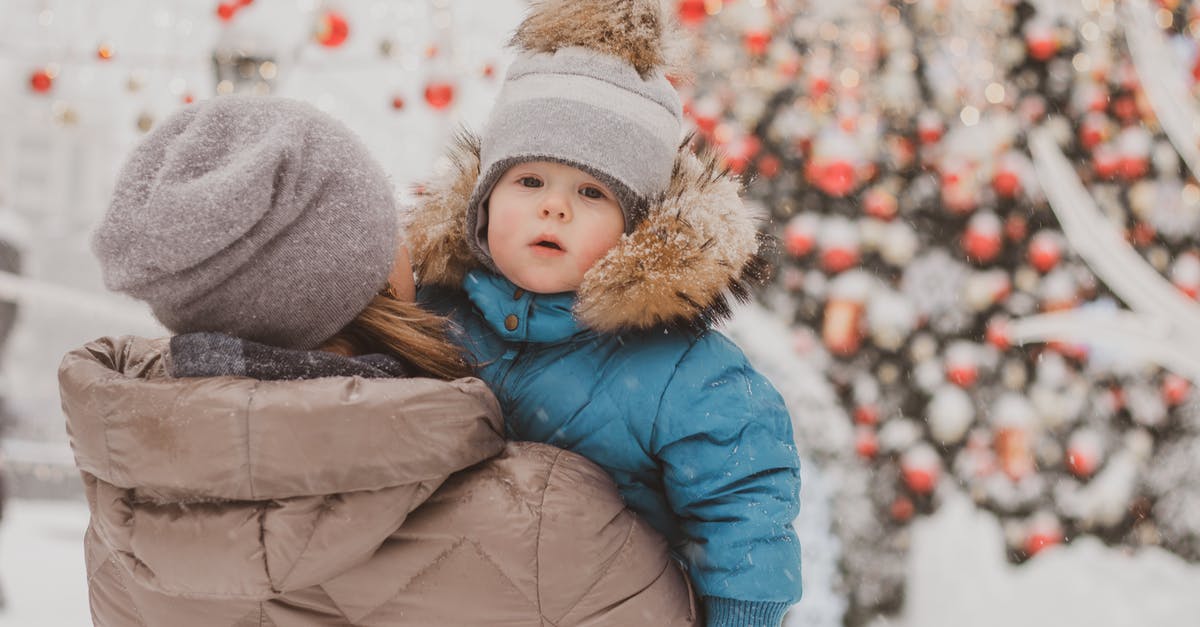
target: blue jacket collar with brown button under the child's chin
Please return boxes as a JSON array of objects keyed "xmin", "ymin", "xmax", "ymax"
[{"xmin": 462, "ymin": 269, "xmax": 586, "ymax": 344}]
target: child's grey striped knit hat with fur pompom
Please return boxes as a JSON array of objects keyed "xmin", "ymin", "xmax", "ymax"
[{"xmin": 467, "ymin": 0, "xmax": 683, "ymax": 271}]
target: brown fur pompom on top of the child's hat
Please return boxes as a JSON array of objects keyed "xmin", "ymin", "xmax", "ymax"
[{"xmin": 510, "ymin": 0, "xmax": 688, "ymax": 78}]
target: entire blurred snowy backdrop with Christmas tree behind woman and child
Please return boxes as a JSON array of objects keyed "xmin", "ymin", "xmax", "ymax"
[{"xmin": 0, "ymin": 0, "xmax": 1200, "ymax": 627}]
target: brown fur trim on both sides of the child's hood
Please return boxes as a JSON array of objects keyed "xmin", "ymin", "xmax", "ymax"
[{"xmin": 407, "ymin": 132, "xmax": 768, "ymax": 333}]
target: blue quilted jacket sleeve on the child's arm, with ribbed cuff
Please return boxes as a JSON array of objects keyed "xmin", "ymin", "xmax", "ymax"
[{"xmin": 652, "ymin": 333, "xmax": 800, "ymax": 627}]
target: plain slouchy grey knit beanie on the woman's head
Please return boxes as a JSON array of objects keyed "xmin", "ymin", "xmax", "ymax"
[{"xmin": 92, "ymin": 96, "xmax": 400, "ymax": 348}]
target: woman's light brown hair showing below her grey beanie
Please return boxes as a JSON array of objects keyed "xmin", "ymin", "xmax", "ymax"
[{"xmin": 320, "ymin": 289, "xmax": 473, "ymax": 380}]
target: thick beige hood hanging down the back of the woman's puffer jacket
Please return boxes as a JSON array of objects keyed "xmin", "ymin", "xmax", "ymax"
[{"xmin": 60, "ymin": 338, "xmax": 504, "ymax": 599}]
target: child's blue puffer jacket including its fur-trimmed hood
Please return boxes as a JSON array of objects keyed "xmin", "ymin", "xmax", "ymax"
[{"xmin": 408, "ymin": 132, "xmax": 800, "ymax": 627}]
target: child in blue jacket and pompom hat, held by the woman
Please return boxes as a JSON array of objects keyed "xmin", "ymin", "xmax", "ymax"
[{"xmin": 409, "ymin": 0, "xmax": 800, "ymax": 626}]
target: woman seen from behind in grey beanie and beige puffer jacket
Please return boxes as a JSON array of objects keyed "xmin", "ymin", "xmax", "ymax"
[{"xmin": 59, "ymin": 97, "xmax": 697, "ymax": 626}]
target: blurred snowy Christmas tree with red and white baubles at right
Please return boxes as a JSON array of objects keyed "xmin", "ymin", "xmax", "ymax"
[{"xmin": 678, "ymin": 0, "xmax": 1200, "ymax": 625}]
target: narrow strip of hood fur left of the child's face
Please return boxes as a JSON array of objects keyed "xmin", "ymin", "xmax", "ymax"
[{"xmin": 404, "ymin": 130, "xmax": 480, "ymax": 287}]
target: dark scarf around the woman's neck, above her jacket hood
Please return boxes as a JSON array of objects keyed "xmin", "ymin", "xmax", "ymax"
[{"xmin": 167, "ymin": 333, "xmax": 408, "ymax": 381}]
